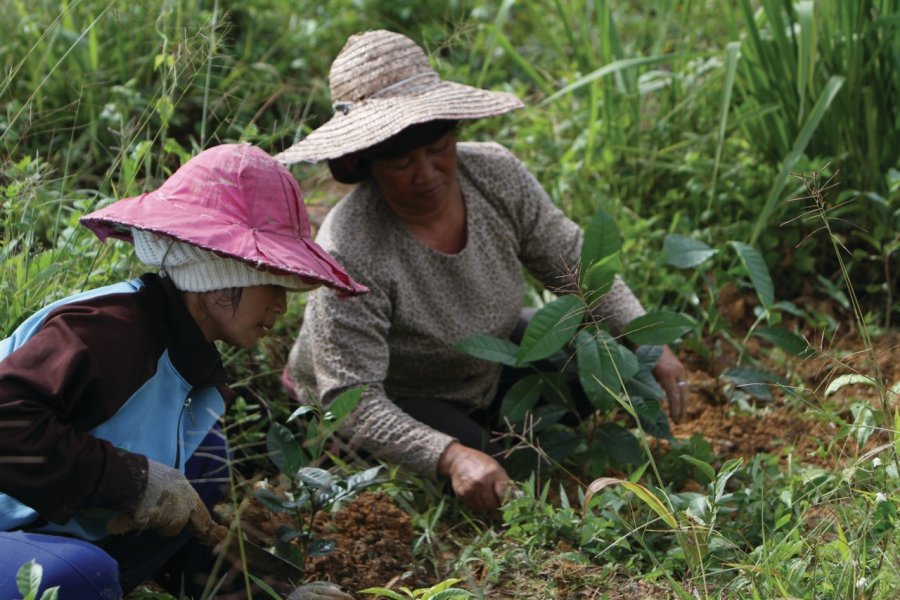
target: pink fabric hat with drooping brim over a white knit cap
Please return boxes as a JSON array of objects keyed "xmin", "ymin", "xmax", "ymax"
[{"xmin": 81, "ymin": 144, "xmax": 367, "ymax": 295}]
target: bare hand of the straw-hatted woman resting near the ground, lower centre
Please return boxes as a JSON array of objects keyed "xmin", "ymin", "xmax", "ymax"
[{"xmin": 438, "ymin": 442, "xmax": 509, "ymax": 512}]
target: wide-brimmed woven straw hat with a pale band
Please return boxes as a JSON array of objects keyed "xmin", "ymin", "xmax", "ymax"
[{"xmin": 275, "ymin": 30, "xmax": 523, "ymax": 164}]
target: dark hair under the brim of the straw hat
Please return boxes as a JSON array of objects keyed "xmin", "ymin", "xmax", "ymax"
[{"xmin": 328, "ymin": 120, "xmax": 459, "ymax": 183}]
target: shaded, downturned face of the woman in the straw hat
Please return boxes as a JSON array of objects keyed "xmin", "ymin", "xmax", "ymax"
[{"xmin": 371, "ymin": 130, "xmax": 458, "ymax": 216}]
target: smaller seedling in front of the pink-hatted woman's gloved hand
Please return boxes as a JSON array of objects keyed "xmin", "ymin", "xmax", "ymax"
[{"xmin": 254, "ymin": 388, "xmax": 381, "ymax": 568}]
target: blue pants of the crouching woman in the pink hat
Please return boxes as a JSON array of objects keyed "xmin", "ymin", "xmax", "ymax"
[{"xmin": 0, "ymin": 427, "xmax": 229, "ymax": 600}]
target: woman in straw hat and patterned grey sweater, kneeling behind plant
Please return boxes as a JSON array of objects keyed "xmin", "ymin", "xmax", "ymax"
[{"xmin": 276, "ymin": 31, "xmax": 684, "ymax": 510}]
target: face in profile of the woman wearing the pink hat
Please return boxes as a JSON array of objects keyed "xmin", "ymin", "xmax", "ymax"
[{"xmin": 188, "ymin": 285, "xmax": 287, "ymax": 348}]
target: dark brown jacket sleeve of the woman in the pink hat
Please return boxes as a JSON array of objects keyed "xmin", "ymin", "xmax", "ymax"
[{"xmin": 0, "ymin": 310, "xmax": 147, "ymax": 523}]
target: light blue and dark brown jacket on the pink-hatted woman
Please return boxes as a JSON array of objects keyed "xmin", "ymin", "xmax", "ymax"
[{"xmin": 0, "ymin": 275, "xmax": 229, "ymax": 539}]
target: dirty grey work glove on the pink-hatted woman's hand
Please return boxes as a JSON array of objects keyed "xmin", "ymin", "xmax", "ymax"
[{"xmin": 106, "ymin": 460, "xmax": 206, "ymax": 537}]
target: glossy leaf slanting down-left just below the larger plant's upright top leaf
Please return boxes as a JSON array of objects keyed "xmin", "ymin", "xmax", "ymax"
[{"xmin": 518, "ymin": 296, "xmax": 585, "ymax": 365}]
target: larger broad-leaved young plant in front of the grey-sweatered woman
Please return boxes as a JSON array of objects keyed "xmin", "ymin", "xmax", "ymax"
[{"xmin": 457, "ymin": 209, "xmax": 694, "ymax": 472}]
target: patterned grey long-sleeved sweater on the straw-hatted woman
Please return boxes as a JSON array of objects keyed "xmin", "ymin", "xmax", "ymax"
[{"xmin": 289, "ymin": 143, "xmax": 644, "ymax": 477}]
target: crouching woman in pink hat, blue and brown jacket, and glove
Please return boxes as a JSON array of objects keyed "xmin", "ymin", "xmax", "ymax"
[{"xmin": 0, "ymin": 144, "xmax": 365, "ymax": 599}]
